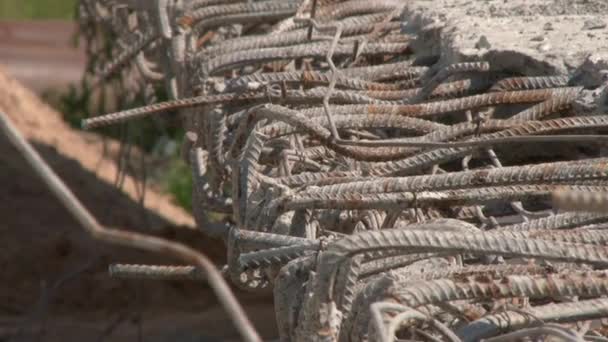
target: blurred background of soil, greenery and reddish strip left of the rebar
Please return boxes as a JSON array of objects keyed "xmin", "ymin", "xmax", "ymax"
[{"xmin": 0, "ymin": 0, "xmax": 275, "ymax": 341}]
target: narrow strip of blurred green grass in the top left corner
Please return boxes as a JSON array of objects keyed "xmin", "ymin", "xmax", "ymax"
[{"xmin": 0, "ymin": 0, "xmax": 78, "ymax": 20}]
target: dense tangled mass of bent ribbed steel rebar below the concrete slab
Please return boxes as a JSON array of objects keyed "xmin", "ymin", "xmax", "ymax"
[{"xmin": 80, "ymin": 0, "xmax": 608, "ymax": 341}]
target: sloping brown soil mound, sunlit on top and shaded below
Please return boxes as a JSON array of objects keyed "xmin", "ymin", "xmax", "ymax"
[{"xmin": 0, "ymin": 71, "xmax": 276, "ymax": 341}]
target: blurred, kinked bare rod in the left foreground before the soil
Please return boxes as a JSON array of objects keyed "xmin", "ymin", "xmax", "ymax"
[{"xmin": 0, "ymin": 112, "xmax": 261, "ymax": 341}]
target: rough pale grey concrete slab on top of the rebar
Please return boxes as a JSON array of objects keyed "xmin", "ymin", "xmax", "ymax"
[{"xmin": 403, "ymin": 0, "xmax": 608, "ymax": 80}]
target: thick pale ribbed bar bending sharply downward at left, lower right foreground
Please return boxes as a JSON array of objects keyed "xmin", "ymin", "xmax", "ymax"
[{"xmin": 296, "ymin": 225, "xmax": 608, "ymax": 336}]
